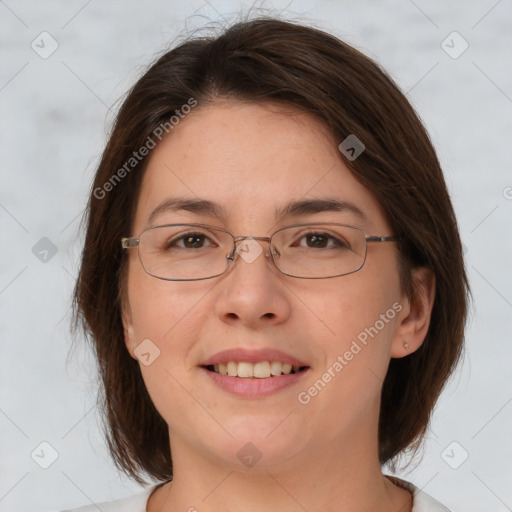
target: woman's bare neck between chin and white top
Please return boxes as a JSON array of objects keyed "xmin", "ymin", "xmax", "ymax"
[{"xmin": 147, "ymin": 412, "xmax": 412, "ymax": 512}]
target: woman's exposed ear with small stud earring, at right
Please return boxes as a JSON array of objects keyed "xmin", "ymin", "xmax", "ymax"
[{"xmin": 391, "ymin": 267, "xmax": 436, "ymax": 358}]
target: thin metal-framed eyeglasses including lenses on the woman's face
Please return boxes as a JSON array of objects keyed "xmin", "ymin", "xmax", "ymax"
[{"xmin": 121, "ymin": 222, "xmax": 400, "ymax": 281}]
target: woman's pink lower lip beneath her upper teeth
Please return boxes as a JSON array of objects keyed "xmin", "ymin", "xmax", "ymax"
[{"xmin": 200, "ymin": 368, "xmax": 309, "ymax": 398}]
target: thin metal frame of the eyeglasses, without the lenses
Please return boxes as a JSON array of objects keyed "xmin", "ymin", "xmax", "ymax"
[{"xmin": 121, "ymin": 222, "xmax": 402, "ymax": 281}]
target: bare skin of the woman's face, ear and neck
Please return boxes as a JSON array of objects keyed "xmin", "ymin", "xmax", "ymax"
[{"xmin": 123, "ymin": 100, "xmax": 435, "ymax": 512}]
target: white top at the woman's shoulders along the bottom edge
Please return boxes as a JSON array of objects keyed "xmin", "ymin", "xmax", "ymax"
[{"xmin": 62, "ymin": 475, "xmax": 450, "ymax": 512}]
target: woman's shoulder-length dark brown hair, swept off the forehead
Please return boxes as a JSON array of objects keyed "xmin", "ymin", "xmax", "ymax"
[{"xmin": 74, "ymin": 17, "xmax": 470, "ymax": 483}]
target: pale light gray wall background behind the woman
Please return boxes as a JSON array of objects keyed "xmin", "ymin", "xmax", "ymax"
[{"xmin": 0, "ymin": 0, "xmax": 512, "ymax": 512}]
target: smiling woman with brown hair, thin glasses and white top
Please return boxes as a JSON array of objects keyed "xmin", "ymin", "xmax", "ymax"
[{"xmin": 68, "ymin": 18, "xmax": 469, "ymax": 512}]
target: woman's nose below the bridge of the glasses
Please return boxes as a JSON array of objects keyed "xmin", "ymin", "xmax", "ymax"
[{"xmin": 214, "ymin": 237, "xmax": 291, "ymax": 329}]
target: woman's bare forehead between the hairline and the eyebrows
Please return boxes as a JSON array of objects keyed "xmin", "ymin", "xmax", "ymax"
[{"xmin": 135, "ymin": 101, "xmax": 385, "ymax": 234}]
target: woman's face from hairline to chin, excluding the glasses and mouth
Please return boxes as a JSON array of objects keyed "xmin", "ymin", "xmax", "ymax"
[{"xmin": 123, "ymin": 102, "xmax": 416, "ymax": 468}]
